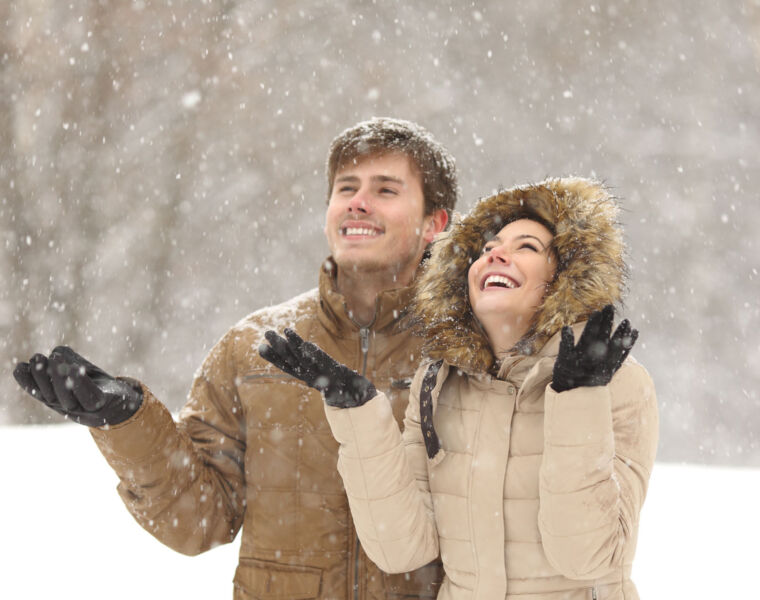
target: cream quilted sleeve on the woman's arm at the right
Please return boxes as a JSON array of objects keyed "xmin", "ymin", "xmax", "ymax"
[{"xmin": 538, "ymin": 359, "xmax": 658, "ymax": 579}]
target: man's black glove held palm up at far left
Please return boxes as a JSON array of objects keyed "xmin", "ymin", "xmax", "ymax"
[{"xmin": 13, "ymin": 346, "xmax": 142, "ymax": 427}]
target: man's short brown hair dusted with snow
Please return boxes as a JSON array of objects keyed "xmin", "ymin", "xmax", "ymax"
[{"xmin": 327, "ymin": 117, "xmax": 458, "ymax": 221}]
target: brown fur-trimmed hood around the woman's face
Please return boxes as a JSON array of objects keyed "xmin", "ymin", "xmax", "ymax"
[{"xmin": 412, "ymin": 177, "xmax": 627, "ymax": 373}]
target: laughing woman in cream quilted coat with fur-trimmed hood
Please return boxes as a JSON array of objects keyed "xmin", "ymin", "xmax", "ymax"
[{"xmin": 260, "ymin": 178, "xmax": 658, "ymax": 600}]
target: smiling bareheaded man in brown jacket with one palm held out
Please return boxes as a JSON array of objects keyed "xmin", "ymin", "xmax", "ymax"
[{"xmin": 14, "ymin": 118, "xmax": 457, "ymax": 600}]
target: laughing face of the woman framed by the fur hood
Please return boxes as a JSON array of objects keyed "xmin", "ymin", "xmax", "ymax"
[{"xmin": 467, "ymin": 219, "xmax": 556, "ymax": 352}]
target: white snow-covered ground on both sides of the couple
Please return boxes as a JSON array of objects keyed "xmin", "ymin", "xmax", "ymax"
[{"xmin": 0, "ymin": 425, "xmax": 760, "ymax": 600}]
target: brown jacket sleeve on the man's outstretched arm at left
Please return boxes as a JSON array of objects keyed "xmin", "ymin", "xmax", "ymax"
[{"xmin": 90, "ymin": 330, "xmax": 245, "ymax": 555}]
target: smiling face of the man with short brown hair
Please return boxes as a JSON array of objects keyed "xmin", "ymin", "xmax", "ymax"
[{"xmin": 325, "ymin": 153, "xmax": 445, "ymax": 285}]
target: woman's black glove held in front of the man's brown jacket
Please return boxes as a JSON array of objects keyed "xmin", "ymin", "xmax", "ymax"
[{"xmin": 259, "ymin": 329, "xmax": 377, "ymax": 408}]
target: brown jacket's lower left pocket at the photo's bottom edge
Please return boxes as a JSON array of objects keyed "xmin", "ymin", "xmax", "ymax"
[{"xmin": 233, "ymin": 558, "xmax": 322, "ymax": 600}]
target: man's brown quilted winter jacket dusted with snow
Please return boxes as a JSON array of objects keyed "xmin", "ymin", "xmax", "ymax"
[{"xmin": 91, "ymin": 263, "xmax": 442, "ymax": 600}]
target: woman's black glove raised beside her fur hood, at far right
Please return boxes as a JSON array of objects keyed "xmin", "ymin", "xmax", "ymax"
[{"xmin": 551, "ymin": 304, "xmax": 639, "ymax": 392}]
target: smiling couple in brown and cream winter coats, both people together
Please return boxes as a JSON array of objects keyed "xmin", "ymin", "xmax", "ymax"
[{"xmin": 14, "ymin": 119, "xmax": 657, "ymax": 599}]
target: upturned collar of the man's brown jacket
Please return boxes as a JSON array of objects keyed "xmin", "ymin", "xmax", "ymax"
[{"xmin": 319, "ymin": 256, "xmax": 413, "ymax": 334}]
